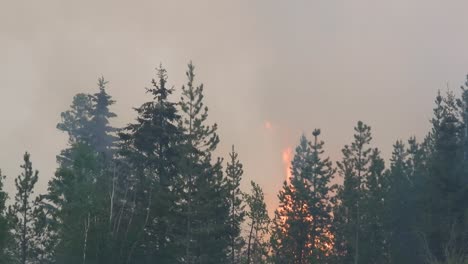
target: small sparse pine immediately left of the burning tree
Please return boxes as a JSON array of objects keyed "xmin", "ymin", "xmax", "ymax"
[{"xmin": 245, "ymin": 181, "xmax": 270, "ymax": 264}]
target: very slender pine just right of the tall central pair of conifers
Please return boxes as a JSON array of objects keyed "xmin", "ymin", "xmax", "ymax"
[{"xmin": 226, "ymin": 146, "xmax": 245, "ymax": 264}]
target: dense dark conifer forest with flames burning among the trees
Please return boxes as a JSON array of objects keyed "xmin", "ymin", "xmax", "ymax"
[{"xmin": 0, "ymin": 63, "xmax": 468, "ymax": 264}]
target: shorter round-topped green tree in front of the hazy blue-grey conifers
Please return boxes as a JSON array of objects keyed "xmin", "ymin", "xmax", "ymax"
[{"xmin": 45, "ymin": 143, "xmax": 102, "ymax": 264}]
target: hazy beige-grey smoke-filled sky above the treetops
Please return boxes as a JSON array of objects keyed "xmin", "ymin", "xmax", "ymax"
[{"xmin": 0, "ymin": 0, "xmax": 468, "ymax": 209}]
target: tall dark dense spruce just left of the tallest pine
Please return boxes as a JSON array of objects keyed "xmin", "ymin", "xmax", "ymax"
[{"xmin": 120, "ymin": 67, "xmax": 182, "ymax": 263}]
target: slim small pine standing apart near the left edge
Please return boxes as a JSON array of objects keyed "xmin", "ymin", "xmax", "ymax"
[{"xmin": 9, "ymin": 152, "xmax": 39, "ymax": 264}]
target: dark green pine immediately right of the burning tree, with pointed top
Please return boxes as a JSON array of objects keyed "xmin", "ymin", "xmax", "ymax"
[{"xmin": 334, "ymin": 121, "xmax": 387, "ymax": 263}]
